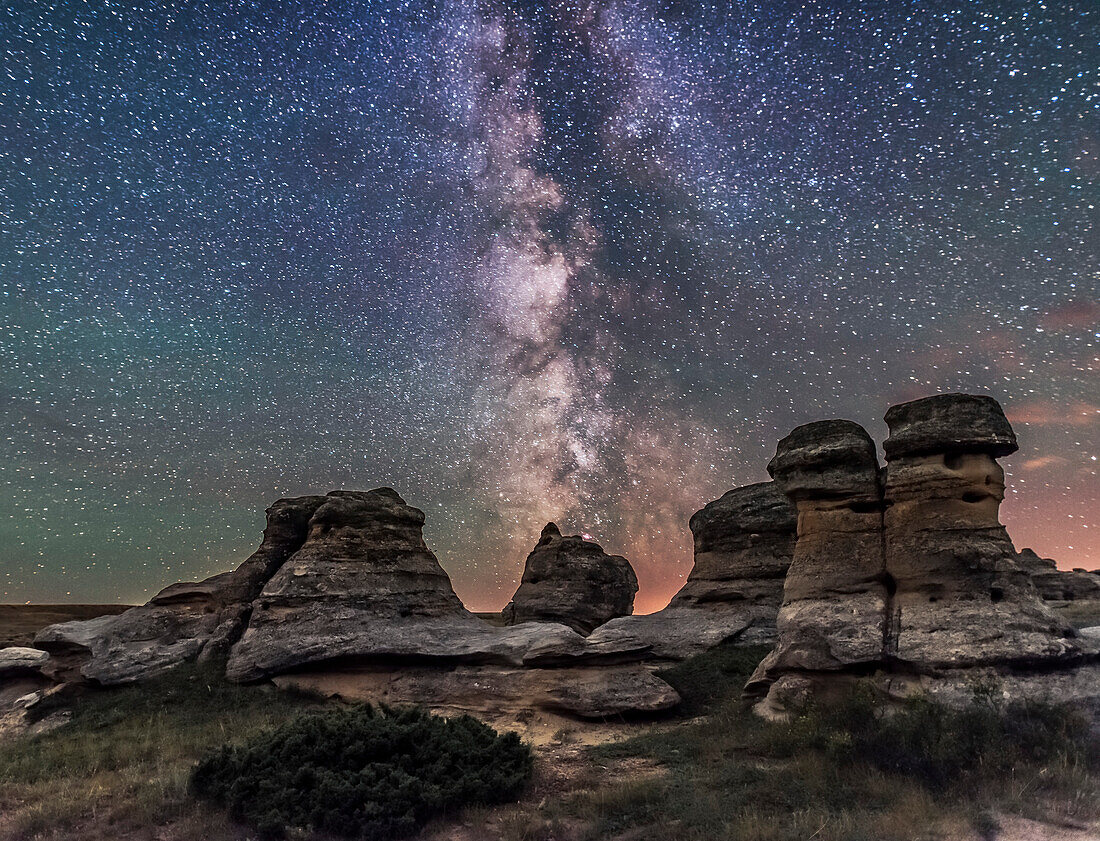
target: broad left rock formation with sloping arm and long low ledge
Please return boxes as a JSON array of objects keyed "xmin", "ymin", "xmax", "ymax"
[{"xmin": 27, "ymin": 488, "xmax": 679, "ymax": 716}]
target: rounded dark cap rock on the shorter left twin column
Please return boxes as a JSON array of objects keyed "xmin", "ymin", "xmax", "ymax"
[{"xmin": 768, "ymin": 420, "xmax": 879, "ymax": 499}]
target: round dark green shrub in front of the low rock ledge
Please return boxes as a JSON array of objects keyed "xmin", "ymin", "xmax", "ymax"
[{"xmin": 191, "ymin": 705, "xmax": 531, "ymax": 841}]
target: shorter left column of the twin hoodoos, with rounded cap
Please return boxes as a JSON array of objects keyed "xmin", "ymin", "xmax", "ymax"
[{"xmin": 746, "ymin": 420, "xmax": 889, "ymax": 711}]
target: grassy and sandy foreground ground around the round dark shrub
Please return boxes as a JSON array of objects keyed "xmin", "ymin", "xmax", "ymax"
[{"xmin": 0, "ymin": 649, "xmax": 1100, "ymax": 841}]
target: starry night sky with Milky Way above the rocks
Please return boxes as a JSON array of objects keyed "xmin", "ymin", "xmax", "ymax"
[{"xmin": 0, "ymin": 0, "xmax": 1100, "ymax": 610}]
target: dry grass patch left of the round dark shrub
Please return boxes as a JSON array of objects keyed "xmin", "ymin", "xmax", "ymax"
[{"xmin": 0, "ymin": 666, "xmax": 317, "ymax": 841}]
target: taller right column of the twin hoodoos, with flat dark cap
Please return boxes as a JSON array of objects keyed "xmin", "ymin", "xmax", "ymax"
[{"xmin": 883, "ymin": 394, "xmax": 1079, "ymax": 671}]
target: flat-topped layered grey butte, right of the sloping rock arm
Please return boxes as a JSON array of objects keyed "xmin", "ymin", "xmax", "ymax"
[{"xmin": 228, "ymin": 488, "xmax": 487, "ymax": 680}]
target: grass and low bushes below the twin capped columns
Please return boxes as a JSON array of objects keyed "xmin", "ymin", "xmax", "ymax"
[{"xmin": 561, "ymin": 649, "xmax": 1100, "ymax": 841}]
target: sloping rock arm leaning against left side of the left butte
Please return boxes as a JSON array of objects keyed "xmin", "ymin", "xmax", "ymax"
[{"xmin": 34, "ymin": 496, "xmax": 326, "ymax": 685}]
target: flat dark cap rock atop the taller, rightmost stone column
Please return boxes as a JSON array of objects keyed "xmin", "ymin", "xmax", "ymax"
[{"xmin": 882, "ymin": 394, "xmax": 1019, "ymax": 461}]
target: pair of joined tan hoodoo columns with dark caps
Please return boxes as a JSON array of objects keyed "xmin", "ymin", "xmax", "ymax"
[{"xmin": 746, "ymin": 395, "xmax": 1100, "ymax": 715}]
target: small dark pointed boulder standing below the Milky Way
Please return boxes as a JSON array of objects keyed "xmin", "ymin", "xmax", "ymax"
[{"xmin": 503, "ymin": 523, "xmax": 638, "ymax": 634}]
